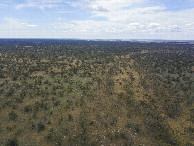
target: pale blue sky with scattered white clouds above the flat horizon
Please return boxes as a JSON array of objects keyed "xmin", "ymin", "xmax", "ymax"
[{"xmin": 0, "ymin": 0, "xmax": 194, "ymax": 40}]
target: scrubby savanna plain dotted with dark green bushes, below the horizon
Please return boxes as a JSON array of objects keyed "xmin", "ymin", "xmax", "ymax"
[{"xmin": 0, "ymin": 39, "xmax": 194, "ymax": 146}]
